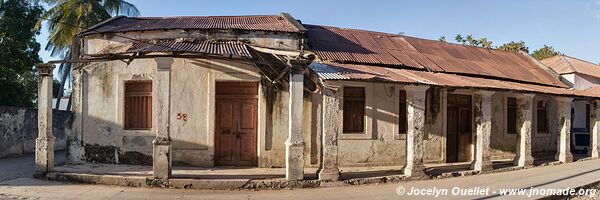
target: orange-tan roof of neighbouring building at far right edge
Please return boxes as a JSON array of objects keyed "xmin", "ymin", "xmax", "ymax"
[{"xmin": 542, "ymin": 55, "xmax": 600, "ymax": 78}]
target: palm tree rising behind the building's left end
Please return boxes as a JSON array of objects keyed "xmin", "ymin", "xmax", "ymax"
[{"xmin": 34, "ymin": 0, "xmax": 140, "ymax": 108}]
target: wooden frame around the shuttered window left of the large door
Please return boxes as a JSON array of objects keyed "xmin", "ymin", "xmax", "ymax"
[{"xmin": 121, "ymin": 80, "xmax": 154, "ymax": 131}]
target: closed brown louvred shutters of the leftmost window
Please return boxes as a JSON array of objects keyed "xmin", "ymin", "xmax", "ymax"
[{"xmin": 123, "ymin": 81, "xmax": 152, "ymax": 130}]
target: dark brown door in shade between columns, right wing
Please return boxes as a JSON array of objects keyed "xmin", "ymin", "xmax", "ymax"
[{"xmin": 446, "ymin": 94, "xmax": 472, "ymax": 162}]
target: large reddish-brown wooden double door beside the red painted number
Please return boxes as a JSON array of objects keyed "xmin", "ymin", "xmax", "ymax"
[{"xmin": 215, "ymin": 82, "xmax": 258, "ymax": 166}]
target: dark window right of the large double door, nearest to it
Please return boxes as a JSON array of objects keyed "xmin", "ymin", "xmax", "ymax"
[{"xmin": 343, "ymin": 87, "xmax": 365, "ymax": 133}]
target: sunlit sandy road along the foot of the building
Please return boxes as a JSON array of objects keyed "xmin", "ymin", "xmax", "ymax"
[{"xmin": 0, "ymin": 156, "xmax": 600, "ymax": 200}]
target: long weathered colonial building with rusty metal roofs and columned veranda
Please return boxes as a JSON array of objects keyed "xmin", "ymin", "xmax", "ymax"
[{"xmin": 35, "ymin": 14, "xmax": 600, "ymax": 180}]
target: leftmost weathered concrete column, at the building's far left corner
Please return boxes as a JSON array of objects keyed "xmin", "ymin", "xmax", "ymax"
[{"xmin": 34, "ymin": 64, "xmax": 54, "ymax": 177}]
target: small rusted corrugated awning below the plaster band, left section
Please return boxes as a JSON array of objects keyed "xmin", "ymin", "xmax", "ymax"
[{"xmin": 126, "ymin": 40, "xmax": 252, "ymax": 58}]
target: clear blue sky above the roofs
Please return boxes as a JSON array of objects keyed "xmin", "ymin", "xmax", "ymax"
[{"xmin": 38, "ymin": 0, "xmax": 600, "ymax": 69}]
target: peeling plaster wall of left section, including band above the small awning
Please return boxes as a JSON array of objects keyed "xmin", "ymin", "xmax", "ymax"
[{"xmin": 76, "ymin": 30, "xmax": 304, "ymax": 167}]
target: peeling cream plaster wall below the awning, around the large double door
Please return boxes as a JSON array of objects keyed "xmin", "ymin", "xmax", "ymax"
[{"xmin": 77, "ymin": 55, "xmax": 298, "ymax": 167}]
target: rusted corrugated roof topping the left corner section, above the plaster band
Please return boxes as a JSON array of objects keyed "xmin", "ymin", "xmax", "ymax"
[{"xmin": 81, "ymin": 15, "xmax": 300, "ymax": 35}]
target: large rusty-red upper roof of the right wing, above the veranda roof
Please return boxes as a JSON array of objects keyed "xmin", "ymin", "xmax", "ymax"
[{"xmin": 305, "ymin": 25, "xmax": 566, "ymax": 87}]
